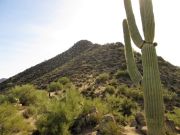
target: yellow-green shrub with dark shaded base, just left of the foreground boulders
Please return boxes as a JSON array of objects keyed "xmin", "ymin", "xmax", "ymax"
[{"xmin": 70, "ymin": 98, "xmax": 109, "ymax": 134}]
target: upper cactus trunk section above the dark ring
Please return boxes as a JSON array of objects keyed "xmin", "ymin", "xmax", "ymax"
[{"xmin": 139, "ymin": 0, "xmax": 155, "ymax": 43}]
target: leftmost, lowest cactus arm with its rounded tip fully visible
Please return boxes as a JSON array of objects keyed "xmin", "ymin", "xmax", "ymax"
[{"xmin": 123, "ymin": 19, "xmax": 142, "ymax": 85}]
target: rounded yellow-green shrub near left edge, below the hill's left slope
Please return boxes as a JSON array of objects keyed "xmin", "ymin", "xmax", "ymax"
[{"xmin": 10, "ymin": 84, "xmax": 37, "ymax": 105}]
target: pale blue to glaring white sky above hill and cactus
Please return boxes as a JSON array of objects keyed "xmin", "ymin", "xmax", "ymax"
[{"xmin": 0, "ymin": 0, "xmax": 180, "ymax": 78}]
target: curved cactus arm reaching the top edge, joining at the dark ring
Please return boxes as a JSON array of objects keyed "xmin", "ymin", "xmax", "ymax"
[{"xmin": 124, "ymin": 0, "xmax": 143, "ymax": 48}]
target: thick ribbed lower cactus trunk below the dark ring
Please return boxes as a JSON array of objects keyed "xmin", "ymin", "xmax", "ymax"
[{"xmin": 142, "ymin": 43, "xmax": 165, "ymax": 135}]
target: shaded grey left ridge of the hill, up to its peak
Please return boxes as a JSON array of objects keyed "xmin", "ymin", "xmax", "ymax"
[{"xmin": 0, "ymin": 40, "xmax": 93, "ymax": 90}]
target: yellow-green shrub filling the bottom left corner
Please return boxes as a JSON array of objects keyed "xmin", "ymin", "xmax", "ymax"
[{"xmin": 0, "ymin": 103, "xmax": 31, "ymax": 135}]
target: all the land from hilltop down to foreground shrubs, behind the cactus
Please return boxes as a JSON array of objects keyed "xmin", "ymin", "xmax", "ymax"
[{"xmin": 0, "ymin": 40, "xmax": 180, "ymax": 135}]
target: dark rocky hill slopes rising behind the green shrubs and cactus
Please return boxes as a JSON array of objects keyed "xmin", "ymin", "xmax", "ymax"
[{"xmin": 0, "ymin": 40, "xmax": 180, "ymax": 95}]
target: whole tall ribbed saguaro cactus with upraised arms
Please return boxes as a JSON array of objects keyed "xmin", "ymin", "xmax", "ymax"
[{"xmin": 123, "ymin": 0, "xmax": 165, "ymax": 135}]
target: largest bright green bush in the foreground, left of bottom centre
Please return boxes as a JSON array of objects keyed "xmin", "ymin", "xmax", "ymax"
[{"xmin": 36, "ymin": 89, "xmax": 83, "ymax": 135}]
